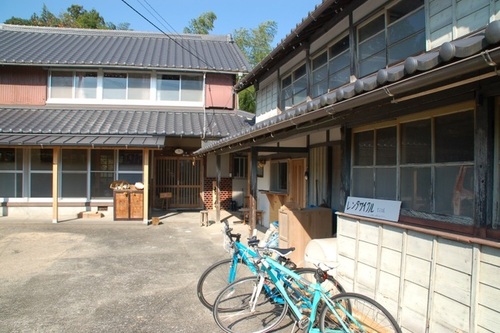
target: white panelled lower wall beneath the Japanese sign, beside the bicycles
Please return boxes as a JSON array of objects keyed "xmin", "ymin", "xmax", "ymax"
[{"xmin": 337, "ymin": 215, "xmax": 500, "ymax": 333}]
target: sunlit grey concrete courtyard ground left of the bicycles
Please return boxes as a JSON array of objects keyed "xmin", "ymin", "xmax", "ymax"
[{"xmin": 0, "ymin": 212, "xmax": 300, "ymax": 332}]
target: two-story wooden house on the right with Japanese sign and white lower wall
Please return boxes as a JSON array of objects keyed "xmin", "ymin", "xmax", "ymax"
[{"xmin": 196, "ymin": 0, "xmax": 500, "ymax": 332}]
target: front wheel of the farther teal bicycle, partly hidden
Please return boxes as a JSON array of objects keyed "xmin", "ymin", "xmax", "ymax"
[{"xmin": 196, "ymin": 258, "xmax": 255, "ymax": 310}]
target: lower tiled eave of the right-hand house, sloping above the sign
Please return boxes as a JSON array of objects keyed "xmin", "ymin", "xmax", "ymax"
[{"xmin": 194, "ymin": 21, "xmax": 500, "ymax": 154}]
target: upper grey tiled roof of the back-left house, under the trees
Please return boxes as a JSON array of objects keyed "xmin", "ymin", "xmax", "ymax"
[{"xmin": 0, "ymin": 24, "xmax": 250, "ymax": 73}]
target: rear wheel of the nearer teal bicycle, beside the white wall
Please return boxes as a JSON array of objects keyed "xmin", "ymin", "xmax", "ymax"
[{"xmin": 319, "ymin": 293, "xmax": 401, "ymax": 333}]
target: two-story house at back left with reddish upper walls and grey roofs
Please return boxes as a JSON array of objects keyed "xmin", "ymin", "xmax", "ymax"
[{"xmin": 0, "ymin": 25, "xmax": 253, "ymax": 222}]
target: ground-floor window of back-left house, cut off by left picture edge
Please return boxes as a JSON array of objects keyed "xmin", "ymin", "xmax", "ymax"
[{"xmin": 0, "ymin": 148, "xmax": 23, "ymax": 198}]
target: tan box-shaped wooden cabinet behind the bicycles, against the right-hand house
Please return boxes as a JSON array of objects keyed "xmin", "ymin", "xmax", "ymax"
[{"xmin": 279, "ymin": 206, "xmax": 332, "ymax": 267}]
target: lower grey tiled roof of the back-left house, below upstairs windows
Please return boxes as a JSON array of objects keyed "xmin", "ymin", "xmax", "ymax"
[{"xmin": 0, "ymin": 107, "xmax": 253, "ymax": 146}]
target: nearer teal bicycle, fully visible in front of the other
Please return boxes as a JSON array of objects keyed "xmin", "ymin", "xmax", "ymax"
[{"xmin": 212, "ymin": 244, "xmax": 401, "ymax": 333}]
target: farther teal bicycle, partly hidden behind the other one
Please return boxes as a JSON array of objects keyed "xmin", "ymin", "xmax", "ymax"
[{"xmin": 196, "ymin": 221, "xmax": 345, "ymax": 310}]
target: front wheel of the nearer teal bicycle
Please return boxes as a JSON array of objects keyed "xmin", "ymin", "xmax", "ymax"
[{"xmin": 213, "ymin": 277, "xmax": 288, "ymax": 333}]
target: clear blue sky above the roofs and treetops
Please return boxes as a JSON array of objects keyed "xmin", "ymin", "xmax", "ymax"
[{"xmin": 0, "ymin": 0, "xmax": 322, "ymax": 47}]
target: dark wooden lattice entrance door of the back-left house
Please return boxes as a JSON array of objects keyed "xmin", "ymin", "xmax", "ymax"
[{"xmin": 153, "ymin": 156, "xmax": 202, "ymax": 209}]
